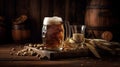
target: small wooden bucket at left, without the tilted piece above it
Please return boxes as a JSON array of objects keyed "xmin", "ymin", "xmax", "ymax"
[{"xmin": 12, "ymin": 25, "xmax": 30, "ymax": 43}]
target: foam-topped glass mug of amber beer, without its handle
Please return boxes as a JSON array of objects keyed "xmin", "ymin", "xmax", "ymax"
[{"xmin": 42, "ymin": 16, "xmax": 64, "ymax": 50}]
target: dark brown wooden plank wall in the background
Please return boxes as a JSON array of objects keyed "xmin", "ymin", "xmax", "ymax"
[{"xmin": 0, "ymin": 0, "xmax": 120, "ymax": 43}]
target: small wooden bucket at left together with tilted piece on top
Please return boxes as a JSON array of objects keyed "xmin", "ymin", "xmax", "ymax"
[{"xmin": 12, "ymin": 15, "xmax": 30, "ymax": 43}]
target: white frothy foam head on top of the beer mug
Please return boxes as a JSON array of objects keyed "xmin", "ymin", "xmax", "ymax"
[{"xmin": 43, "ymin": 16, "xmax": 62, "ymax": 25}]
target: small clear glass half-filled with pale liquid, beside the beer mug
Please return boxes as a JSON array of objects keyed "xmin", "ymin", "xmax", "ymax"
[{"xmin": 70, "ymin": 25, "xmax": 86, "ymax": 47}]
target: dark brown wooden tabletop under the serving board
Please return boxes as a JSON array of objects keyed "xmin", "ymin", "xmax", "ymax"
[{"xmin": 0, "ymin": 44, "xmax": 120, "ymax": 67}]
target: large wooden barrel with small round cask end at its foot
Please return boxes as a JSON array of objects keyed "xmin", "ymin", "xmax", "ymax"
[{"xmin": 85, "ymin": 0, "xmax": 118, "ymax": 41}]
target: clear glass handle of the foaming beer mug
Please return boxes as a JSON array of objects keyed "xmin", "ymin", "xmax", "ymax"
[{"xmin": 64, "ymin": 21, "xmax": 71, "ymax": 40}]
